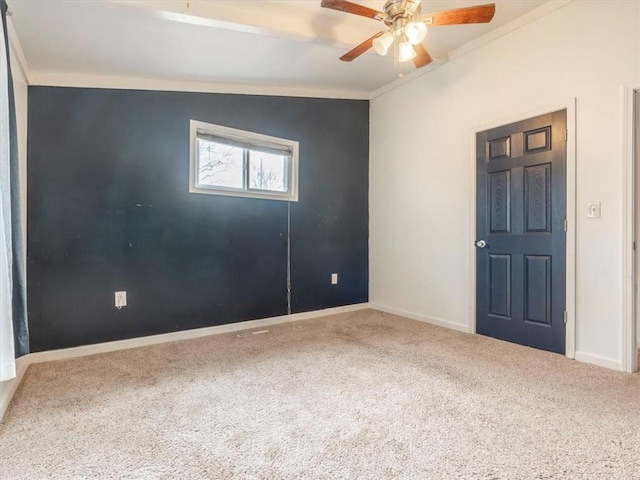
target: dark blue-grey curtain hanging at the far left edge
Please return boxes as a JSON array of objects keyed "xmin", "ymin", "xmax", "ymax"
[{"xmin": 0, "ymin": 0, "xmax": 29, "ymax": 358}]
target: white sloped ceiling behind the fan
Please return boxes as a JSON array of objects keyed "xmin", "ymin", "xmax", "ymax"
[{"xmin": 8, "ymin": 0, "xmax": 547, "ymax": 97}]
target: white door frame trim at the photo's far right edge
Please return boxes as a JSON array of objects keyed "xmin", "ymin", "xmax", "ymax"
[{"xmin": 622, "ymin": 81, "xmax": 640, "ymax": 372}]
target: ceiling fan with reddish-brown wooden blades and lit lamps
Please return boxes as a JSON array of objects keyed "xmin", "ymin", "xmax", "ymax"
[{"xmin": 321, "ymin": 0, "xmax": 496, "ymax": 76}]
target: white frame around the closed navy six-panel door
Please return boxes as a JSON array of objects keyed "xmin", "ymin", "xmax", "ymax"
[{"xmin": 469, "ymin": 98, "xmax": 576, "ymax": 358}]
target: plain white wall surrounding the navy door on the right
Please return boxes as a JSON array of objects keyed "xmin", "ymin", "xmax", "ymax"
[{"xmin": 370, "ymin": 0, "xmax": 640, "ymax": 368}]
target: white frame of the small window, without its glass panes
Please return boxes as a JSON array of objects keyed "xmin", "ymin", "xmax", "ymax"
[{"xmin": 189, "ymin": 120, "xmax": 299, "ymax": 202}]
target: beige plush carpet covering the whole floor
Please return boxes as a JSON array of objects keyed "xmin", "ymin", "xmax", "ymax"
[{"xmin": 0, "ymin": 310, "xmax": 640, "ymax": 479}]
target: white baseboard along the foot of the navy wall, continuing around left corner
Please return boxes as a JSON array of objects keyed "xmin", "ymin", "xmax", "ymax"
[{"xmin": 0, "ymin": 303, "xmax": 369, "ymax": 420}]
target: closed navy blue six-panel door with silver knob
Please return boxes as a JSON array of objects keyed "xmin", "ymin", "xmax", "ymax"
[{"xmin": 476, "ymin": 110, "xmax": 567, "ymax": 354}]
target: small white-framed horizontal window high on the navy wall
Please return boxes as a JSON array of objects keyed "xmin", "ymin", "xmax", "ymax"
[{"xmin": 189, "ymin": 120, "xmax": 298, "ymax": 202}]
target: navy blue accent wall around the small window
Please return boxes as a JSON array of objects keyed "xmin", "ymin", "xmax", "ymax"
[{"xmin": 27, "ymin": 87, "xmax": 369, "ymax": 352}]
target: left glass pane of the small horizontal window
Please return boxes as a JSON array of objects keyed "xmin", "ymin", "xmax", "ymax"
[{"xmin": 197, "ymin": 138, "xmax": 244, "ymax": 188}]
